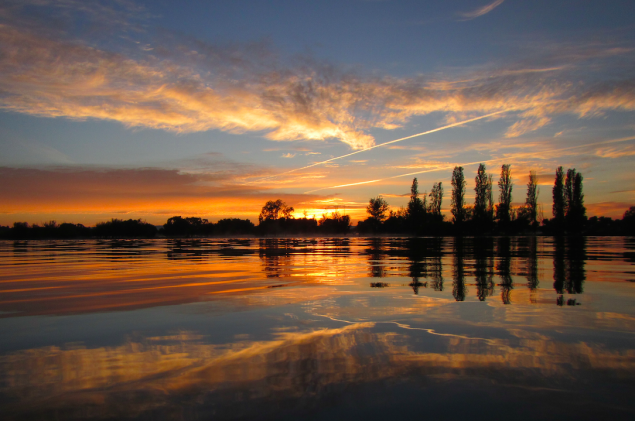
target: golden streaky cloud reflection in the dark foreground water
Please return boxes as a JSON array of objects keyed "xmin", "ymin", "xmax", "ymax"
[{"xmin": 0, "ymin": 323, "xmax": 635, "ymax": 418}]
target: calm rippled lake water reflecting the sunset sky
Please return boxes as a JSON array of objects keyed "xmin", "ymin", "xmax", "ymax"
[{"xmin": 0, "ymin": 237, "xmax": 635, "ymax": 420}]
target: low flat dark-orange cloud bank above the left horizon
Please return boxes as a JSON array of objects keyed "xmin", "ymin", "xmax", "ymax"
[{"xmin": 0, "ymin": 165, "xmax": 317, "ymax": 224}]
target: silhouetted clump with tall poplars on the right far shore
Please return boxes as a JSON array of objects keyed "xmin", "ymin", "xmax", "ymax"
[{"xmin": 358, "ymin": 164, "xmax": 635, "ymax": 235}]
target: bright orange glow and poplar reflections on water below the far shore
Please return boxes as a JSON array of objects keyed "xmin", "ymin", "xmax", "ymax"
[{"xmin": 0, "ymin": 237, "xmax": 620, "ymax": 315}]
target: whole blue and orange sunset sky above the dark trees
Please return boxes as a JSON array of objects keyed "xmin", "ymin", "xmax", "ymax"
[{"xmin": 0, "ymin": 0, "xmax": 635, "ymax": 226}]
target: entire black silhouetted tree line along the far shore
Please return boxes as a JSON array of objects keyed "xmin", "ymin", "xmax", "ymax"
[{"xmin": 0, "ymin": 164, "xmax": 635, "ymax": 239}]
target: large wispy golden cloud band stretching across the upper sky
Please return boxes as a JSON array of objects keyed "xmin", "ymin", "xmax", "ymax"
[{"xmin": 0, "ymin": 1, "xmax": 635, "ymax": 150}]
